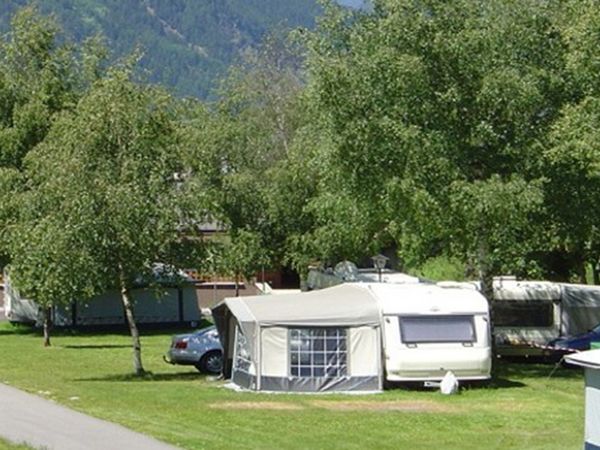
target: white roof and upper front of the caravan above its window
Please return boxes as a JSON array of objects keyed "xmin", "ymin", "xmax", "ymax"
[{"xmin": 367, "ymin": 283, "xmax": 488, "ymax": 314}]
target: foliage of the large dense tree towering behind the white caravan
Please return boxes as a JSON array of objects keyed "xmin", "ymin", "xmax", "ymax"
[{"xmin": 298, "ymin": 0, "xmax": 595, "ymax": 284}]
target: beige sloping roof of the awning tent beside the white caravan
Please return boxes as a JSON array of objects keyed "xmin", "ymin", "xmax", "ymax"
[{"xmin": 215, "ymin": 284, "xmax": 380, "ymax": 326}]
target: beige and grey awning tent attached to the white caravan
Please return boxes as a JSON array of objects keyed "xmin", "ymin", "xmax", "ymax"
[{"xmin": 213, "ymin": 284, "xmax": 383, "ymax": 392}]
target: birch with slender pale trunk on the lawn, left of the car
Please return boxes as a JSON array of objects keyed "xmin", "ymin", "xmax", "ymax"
[{"xmin": 14, "ymin": 67, "xmax": 181, "ymax": 375}]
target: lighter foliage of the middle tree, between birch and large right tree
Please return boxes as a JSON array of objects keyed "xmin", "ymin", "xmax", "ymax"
[{"xmin": 186, "ymin": 32, "xmax": 306, "ymax": 274}]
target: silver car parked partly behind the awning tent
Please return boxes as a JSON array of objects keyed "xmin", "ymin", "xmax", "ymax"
[{"xmin": 164, "ymin": 326, "xmax": 223, "ymax": 374}]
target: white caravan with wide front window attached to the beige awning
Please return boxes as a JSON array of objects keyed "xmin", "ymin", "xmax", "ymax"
[{"xmin": 366, "ymin": 283, "xmax": 492, "ymax": 382}]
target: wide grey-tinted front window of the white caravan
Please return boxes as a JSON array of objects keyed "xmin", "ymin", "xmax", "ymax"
[{"xmin": 399, "ymin": 316, "xmax": 477, "ymax": 344}]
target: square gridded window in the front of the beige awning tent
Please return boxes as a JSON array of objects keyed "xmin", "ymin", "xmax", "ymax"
[{"xmin": 289, "ymin": 328, "xmax": 348, "ymax": 378}]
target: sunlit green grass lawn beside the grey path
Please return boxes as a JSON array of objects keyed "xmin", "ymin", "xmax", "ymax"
[{"xmin": 0, "ymin": 323, "xmax": 583, "ymax": 450}]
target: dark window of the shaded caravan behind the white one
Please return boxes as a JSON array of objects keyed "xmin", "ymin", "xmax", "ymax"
[{"xmin": 492, "ymin": 300, "xmax": 554, "ymax": 327}]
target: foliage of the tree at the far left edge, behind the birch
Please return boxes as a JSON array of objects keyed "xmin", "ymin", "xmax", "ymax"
[{"xmin": 0, "ymin": 7, "xmax": 102, "ymax": 274}]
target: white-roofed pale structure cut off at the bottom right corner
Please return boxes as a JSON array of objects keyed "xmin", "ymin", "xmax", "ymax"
[{"xmin": 565, "ymin": 350, "xmax": 600, "ymax": 450}]
